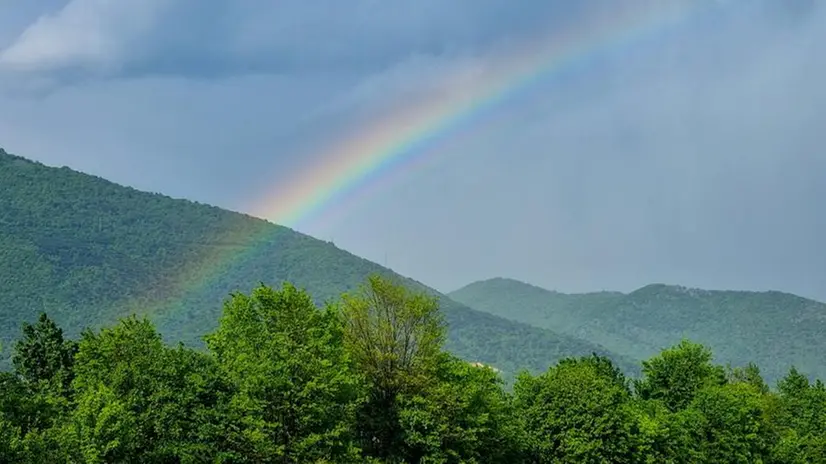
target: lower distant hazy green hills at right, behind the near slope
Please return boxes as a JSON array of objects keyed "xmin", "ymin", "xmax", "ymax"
[{"xmin": 448, "ymin": 278, "xmax": 826, "ymax": 381}]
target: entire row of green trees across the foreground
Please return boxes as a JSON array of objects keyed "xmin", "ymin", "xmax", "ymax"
[{"xmin": 0, "ymin": 276, "xmax": 826, "ymax": 464}]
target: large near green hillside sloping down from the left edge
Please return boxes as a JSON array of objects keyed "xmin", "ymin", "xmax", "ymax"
[{"xmin": 0, "ymin": 150, "xmax": 636, "ymax": 380}]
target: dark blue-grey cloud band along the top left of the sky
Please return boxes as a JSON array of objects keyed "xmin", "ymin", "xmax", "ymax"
[{"xmin": 0, "ymin": 0, "xmax": 592, "ymax": 80}]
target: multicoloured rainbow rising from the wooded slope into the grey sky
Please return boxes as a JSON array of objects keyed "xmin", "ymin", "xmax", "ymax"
[{"xmin": 140, "ymin": 0, "xmax": 705, "ymax": 318}]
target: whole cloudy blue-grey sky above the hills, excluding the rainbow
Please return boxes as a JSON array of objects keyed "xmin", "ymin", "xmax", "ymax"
[{"xmin": 0, "ymin": 0, "xmax": 826, "ymax": 301}]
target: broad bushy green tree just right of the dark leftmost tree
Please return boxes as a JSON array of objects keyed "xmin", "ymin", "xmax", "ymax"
[{"xmin": 68, "ymin": 317, "xmax": 231, "ymax": 463}]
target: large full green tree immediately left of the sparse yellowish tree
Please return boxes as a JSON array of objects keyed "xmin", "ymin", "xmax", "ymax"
[{"xmin": 206, "ymin": 283, "xmax": 361, "ymax": 463}]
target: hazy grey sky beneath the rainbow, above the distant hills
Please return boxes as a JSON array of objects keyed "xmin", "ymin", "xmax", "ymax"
[{"xmin": 308, "ymin": 0, "xmax": 826, "ymax": 299}]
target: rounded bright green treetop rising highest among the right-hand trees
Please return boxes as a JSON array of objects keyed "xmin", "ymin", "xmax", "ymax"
[{"xmin": 635, "ymin": 340, "xmax": 726, "ymax": 412}]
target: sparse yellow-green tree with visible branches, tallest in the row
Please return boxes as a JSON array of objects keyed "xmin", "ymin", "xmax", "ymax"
[{"xmin": 340, "ymin": 275, "xmax": 446, "ymax": 461}]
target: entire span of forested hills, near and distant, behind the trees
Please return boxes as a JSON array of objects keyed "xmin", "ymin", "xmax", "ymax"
[{"xmin": 0, "ymin": 146, "xmax": 826, "ymax": 380}]
